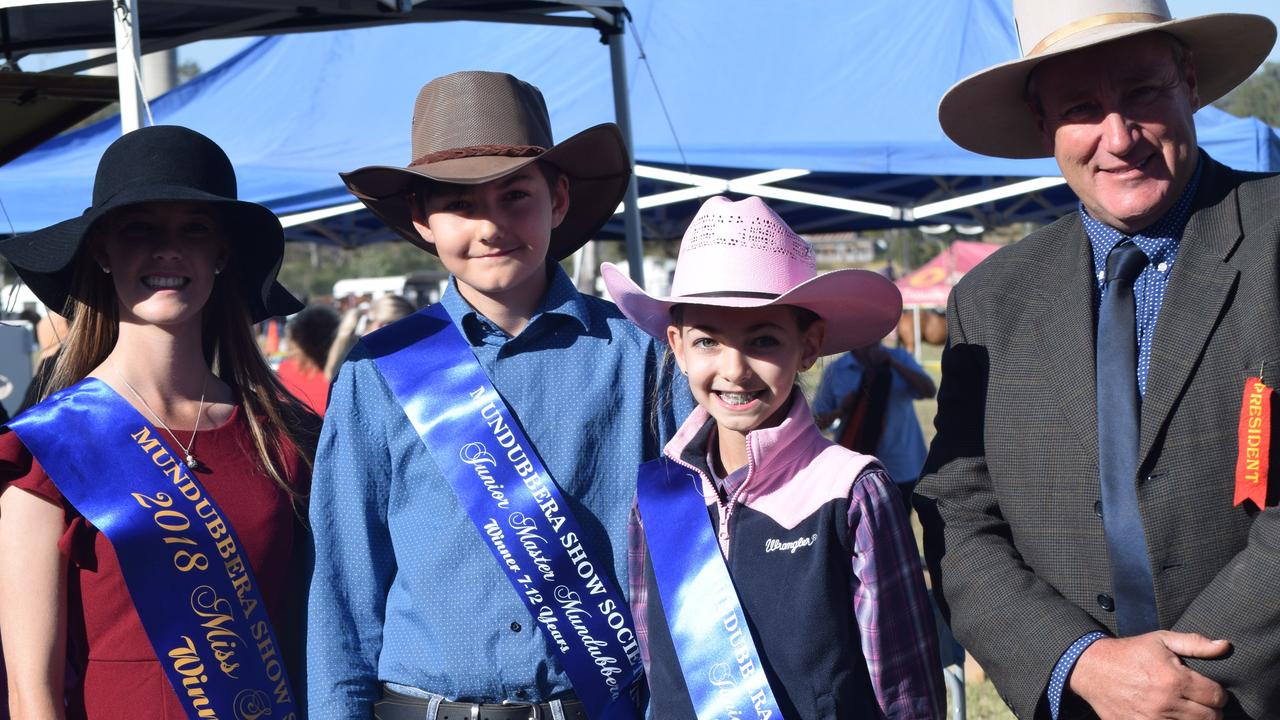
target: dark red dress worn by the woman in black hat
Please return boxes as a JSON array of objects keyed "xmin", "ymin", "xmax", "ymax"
[{"xmin": 0, "ymin": 407, "xmax": 306, "ymax": 720}]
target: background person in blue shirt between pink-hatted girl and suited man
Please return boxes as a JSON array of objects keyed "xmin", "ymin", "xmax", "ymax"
[{"xmin": 813, "ymin": 342, "xmax": 937, "ymax": 514}]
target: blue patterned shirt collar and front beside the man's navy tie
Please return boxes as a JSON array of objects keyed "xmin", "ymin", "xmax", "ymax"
[{"xmin": 1080, "ymin": 163, "xmax": 1202, "ymax": 396}]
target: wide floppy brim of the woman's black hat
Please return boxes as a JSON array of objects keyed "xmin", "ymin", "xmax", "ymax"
[{"xmin": 0, "ymin": 184, "xmax": 303, "ymax": 323}]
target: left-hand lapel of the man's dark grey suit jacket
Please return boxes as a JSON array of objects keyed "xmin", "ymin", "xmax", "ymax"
[{"xmin": 1034, "ymin": 215, "xmax": 1098, "ymax": 459}]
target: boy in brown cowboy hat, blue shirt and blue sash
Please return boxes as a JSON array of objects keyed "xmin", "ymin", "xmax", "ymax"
[{"xmin": 308, "ymin": 72, "xmax": 689, "ymax": 719}]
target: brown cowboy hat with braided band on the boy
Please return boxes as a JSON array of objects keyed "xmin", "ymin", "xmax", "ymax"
[{"xmin": 340, "ymin": 70, "xmax": 631, "ymax": 260}]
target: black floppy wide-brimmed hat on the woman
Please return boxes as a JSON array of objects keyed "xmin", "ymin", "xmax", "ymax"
[{"xmin": 0, "ymin": 126, "xmax": 303, "ymax": 323}]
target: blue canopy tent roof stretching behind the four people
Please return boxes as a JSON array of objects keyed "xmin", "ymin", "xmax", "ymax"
[{"xmin": 0, "ymin": 0, "xmax": 1280, "ymax": 243}]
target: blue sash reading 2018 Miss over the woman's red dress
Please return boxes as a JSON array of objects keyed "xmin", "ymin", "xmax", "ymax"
[{"xmin": 9, "ymin": 378, "xmax": 298, "ymax": 720}]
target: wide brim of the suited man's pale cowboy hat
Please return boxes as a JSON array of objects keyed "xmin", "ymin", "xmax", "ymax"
[{"xmin": 938, "ymin": 13, "xmax": 1276, "ymax": 159}]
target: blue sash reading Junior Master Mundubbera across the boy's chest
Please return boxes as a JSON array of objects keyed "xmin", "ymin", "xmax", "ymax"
[{"xmin": 364, "ymin": 304, "xmax": 644, "ymax": 719}]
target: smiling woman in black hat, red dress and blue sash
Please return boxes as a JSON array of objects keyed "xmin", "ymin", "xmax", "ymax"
[{"xmin": 0, "ymin": 126, "xmax": 319, "ymax": 719}]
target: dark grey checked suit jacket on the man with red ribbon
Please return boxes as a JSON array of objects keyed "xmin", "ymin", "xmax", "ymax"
[{"xmin": 916, "ymin": 156, "xmax": 1280, "ymax": 719}]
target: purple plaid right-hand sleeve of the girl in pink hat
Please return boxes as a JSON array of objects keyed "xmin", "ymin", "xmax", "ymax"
[{"xmin": 849, "ymin": 466, "xmax": 947, "ymax": 720}]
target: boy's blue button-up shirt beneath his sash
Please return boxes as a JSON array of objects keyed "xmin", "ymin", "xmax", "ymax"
[{"xmin": 307, "ymin": 264, "xmax": 692, "ymax": 720}]
